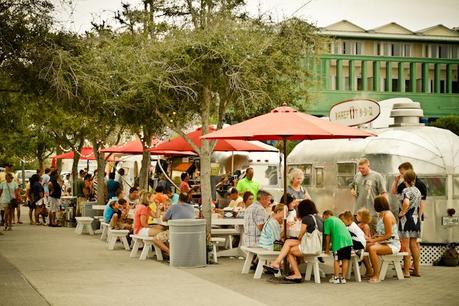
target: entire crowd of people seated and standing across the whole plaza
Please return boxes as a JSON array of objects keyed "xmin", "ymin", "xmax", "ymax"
[{"xmin": 0, "ymin": 159, "xmax": 427, "ymax": 284}]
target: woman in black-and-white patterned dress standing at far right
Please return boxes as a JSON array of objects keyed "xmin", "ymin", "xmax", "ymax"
[{"xmin": 398, "ymin": 170, "xmax": 422, "ymax": 278}]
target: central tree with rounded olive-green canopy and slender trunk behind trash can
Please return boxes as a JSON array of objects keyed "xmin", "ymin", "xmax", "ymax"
[{"xmin": 113, "ymin": 1, "xmax": 320, "ymax": 233}]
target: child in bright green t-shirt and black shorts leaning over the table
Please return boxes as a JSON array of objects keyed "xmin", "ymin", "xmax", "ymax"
[{"xmin": 323, "ymin": 210, "xmax": 352, "ymax": 284}]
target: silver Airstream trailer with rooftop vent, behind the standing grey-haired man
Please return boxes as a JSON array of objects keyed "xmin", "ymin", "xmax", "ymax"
[{"xmin": 287, "ymin": 102, "xmax": 459, "ymax": 243}]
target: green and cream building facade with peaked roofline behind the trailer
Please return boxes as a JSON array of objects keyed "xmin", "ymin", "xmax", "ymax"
[{"xmin": 308, "ymin": 20, "xmax": 459, "ymax": 118}]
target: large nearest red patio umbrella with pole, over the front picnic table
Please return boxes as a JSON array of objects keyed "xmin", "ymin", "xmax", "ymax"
[{"xmin": 202, "ymin": 104, "xmax": 375, "ymax": 240}]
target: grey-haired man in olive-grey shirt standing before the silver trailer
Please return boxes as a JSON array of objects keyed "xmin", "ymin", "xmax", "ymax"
[{"xmin": 351, "ymin": 158, "xmax": 387, "ymax": 232}]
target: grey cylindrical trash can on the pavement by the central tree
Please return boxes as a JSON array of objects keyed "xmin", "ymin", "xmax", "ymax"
[{"xmin": 168, "ymin": 219, "xmax": 206, "ymax": 268}]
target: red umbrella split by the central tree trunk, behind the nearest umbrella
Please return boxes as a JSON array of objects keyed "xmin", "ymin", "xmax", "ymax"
[{"xmin": 150, "ymin": 128, "xmax": 276, "ymax": 154}]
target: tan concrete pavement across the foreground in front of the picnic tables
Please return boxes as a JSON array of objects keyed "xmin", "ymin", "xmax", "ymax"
[{"xmin": 0, "ymin": 216, "xmax": 459, "ymax": 306}]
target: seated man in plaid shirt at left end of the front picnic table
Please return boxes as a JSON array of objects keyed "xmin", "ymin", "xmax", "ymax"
[{"xmin": 244, "ymin": 190, "xmax": 271, "ymax": 247}]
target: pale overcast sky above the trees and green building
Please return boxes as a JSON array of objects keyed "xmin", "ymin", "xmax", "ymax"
[{"xmin": 52, "ymin": 0, "xmax": 459, "ymax": 32}]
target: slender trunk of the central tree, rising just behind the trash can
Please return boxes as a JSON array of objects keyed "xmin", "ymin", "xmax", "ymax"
[{"xmin": 200, "ymin": 87, "xmax": 212, "ymax": 237}]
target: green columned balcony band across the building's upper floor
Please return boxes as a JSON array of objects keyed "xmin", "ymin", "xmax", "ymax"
[{"xmin": 314, "ymin": 55, "xmax": 459, "ymax": 94}]
